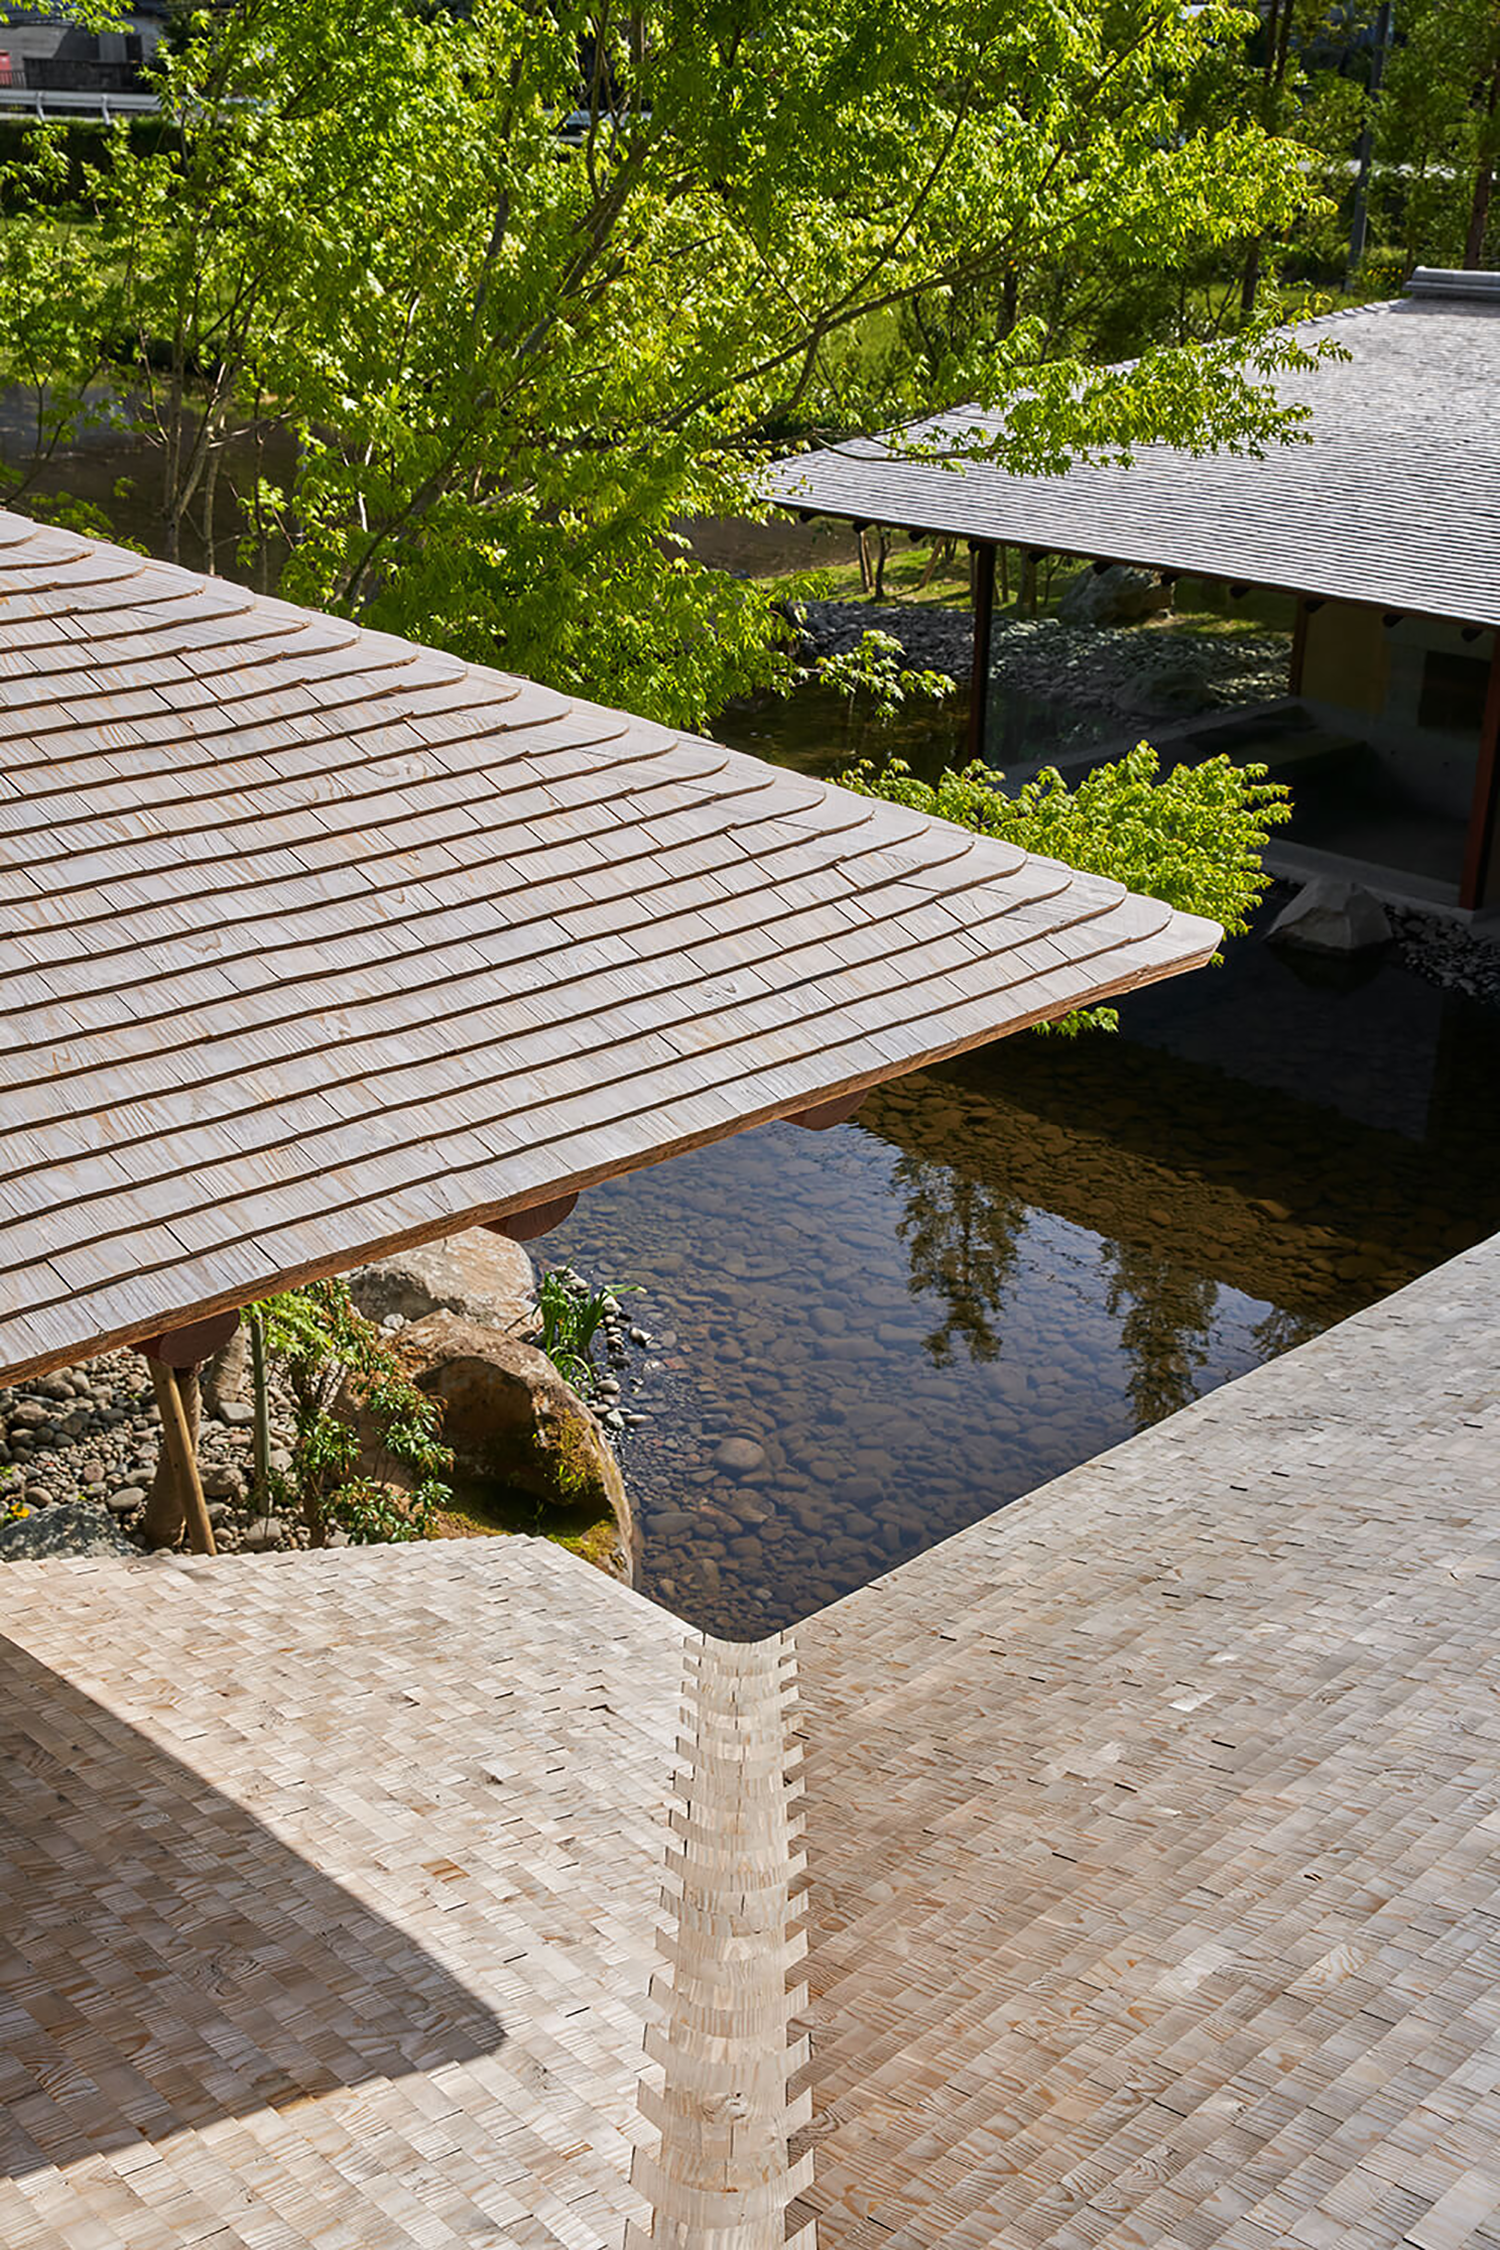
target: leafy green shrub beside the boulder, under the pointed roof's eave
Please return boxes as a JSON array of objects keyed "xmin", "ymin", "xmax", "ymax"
[{"xmin": 254, "ymin": 1280, "xmax": 452, "ymax": 1546}]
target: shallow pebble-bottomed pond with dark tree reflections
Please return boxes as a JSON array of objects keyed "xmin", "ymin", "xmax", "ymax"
[{"xmin": 546, "ymin": 895, "xmax": 1500, "ymax": 1636}]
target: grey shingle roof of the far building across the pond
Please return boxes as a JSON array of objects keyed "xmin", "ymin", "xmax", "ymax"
[{"xmin": 767, "ymin": 288, "xmax": 1500, "ymax": 626}]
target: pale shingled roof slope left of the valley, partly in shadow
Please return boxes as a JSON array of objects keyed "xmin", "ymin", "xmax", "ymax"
[{"xmin": 0, "ymin": 1539, "xmax": 686, "ymax": 2250}]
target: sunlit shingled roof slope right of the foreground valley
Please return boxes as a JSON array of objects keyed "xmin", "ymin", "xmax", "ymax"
[{"xmin": 796, "ymin": 1242, "xmax": 1500, "ymax": 2250}]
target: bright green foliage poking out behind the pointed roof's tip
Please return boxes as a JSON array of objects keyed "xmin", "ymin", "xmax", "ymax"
[{"xmin": 846, "ymin": 743, "xmax": 1291, "ymax": 1031}]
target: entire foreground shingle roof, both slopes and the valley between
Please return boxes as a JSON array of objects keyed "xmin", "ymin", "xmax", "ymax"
[{"xmin": 0, "ymin": 1240, "xmax": 1500, "ymax": 2250}]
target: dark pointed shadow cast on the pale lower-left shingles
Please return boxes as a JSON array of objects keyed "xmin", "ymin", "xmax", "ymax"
[{"xmin": 0, "ymin": 1638, "xmax": 504, "ymax": 2178}]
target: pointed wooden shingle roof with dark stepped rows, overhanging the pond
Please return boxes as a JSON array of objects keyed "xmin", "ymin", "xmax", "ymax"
[{"xmin": 0, "ymin": 513, "xmax": 1219, "ymax": 1377}]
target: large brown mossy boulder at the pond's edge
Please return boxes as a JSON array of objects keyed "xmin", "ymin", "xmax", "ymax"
[{"xmin": 400, "ymin": 1312, "xmax": 634, "ymax": 1557}]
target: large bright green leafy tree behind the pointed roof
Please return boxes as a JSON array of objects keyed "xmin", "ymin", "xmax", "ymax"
[{"xmin": 0, "ymin": 0, "xmax": 1307, "ymax": 725}]
